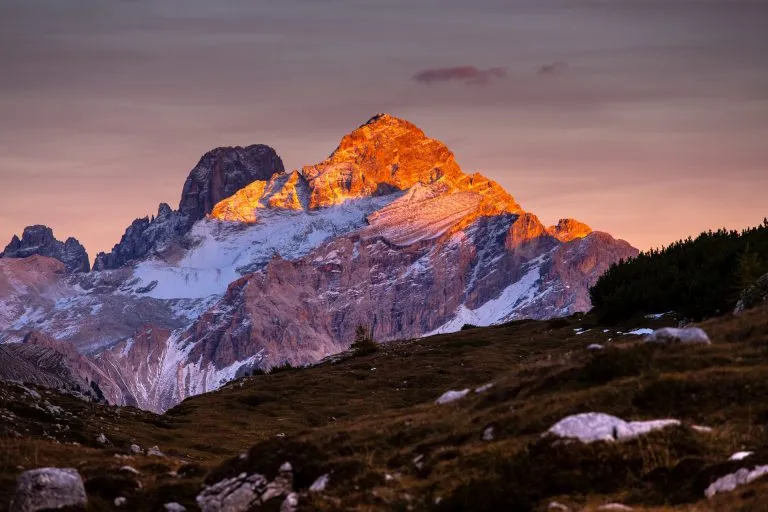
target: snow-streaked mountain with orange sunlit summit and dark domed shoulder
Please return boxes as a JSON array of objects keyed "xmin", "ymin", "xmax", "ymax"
[{"xmin": 0, "ymin": 114, "xmax": 637, "ymax": 410}]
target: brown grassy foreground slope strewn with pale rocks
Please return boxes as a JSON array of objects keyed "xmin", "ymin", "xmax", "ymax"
[{"xmin": 0, "ymin": 309, "xmax": 768, "ymax": 510}]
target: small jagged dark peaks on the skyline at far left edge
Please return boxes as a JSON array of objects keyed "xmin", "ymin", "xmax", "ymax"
[{"xmin": 0, "ymin": 225, "xmax": 91, "ymax": 273}]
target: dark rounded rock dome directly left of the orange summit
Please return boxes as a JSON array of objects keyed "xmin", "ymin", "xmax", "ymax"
[{"xmin": 179, "ymin": 144, "xmax": 284, "ymax": 226}]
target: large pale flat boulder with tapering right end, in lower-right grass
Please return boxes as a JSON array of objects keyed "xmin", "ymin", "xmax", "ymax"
[{"xmin": 547, "ymin": 412, "xmax": 680, "ymax": 443}]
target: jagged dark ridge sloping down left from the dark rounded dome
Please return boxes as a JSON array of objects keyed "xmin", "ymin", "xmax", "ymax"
[{"xmin": 93, "ymin": 203, "xmax": 188, "ymax": 270}]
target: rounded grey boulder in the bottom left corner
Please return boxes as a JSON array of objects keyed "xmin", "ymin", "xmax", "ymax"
[{"xmin": 10, "ymin": 468, "xmax": 88, "ymax": 512}]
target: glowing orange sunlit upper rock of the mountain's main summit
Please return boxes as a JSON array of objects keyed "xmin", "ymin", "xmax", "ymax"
[{"xmin": 211, "ymin": 114, "xmax": 522, "ymax": 239}]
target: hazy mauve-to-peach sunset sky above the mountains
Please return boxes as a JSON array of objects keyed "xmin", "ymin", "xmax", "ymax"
[{"xmin": 0, "ymin": 0, "xmax": 768, "ymax": 258}]
